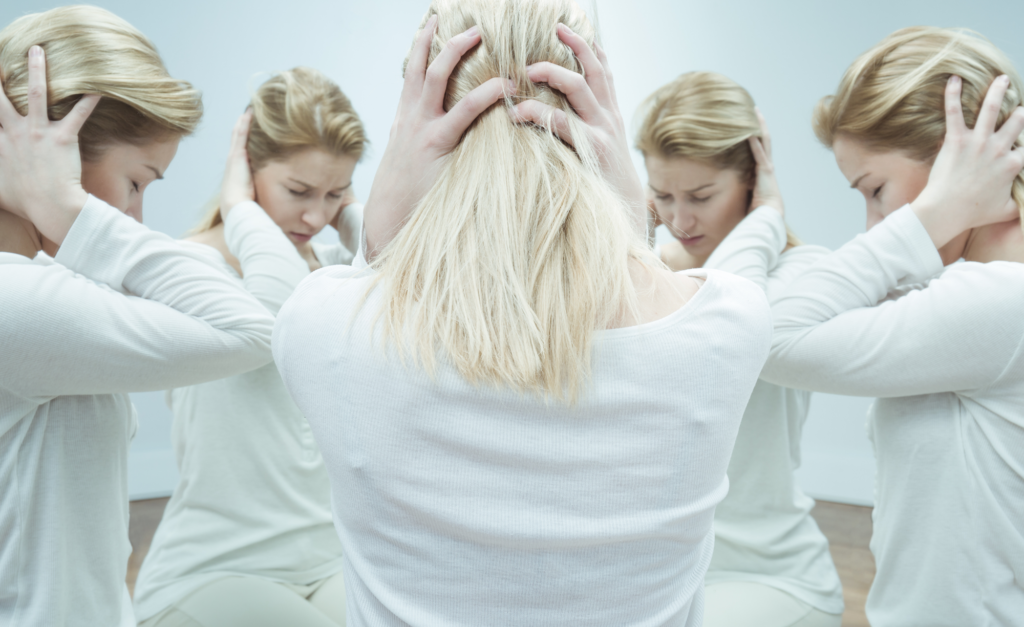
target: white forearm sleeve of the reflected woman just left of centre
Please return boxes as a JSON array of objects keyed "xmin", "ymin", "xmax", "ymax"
[{"xmin": 224, "ymin": 202, "xmax": 309, "ymax": 315}]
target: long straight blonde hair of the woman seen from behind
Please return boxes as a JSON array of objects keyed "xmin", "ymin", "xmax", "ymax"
[{"xmin": 374, "ymin": 0, "xmax": 660, "ymax": 402}]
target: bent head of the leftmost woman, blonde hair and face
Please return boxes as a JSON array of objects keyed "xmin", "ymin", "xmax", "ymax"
[{"xmin": 0, "ymin": 6, "xmax": 203, "ymax": 220}]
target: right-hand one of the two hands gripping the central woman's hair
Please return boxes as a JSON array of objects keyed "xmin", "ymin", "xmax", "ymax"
[{"xmin": 511, "ymin": 24, "xmax": 647, "ymax": 227}]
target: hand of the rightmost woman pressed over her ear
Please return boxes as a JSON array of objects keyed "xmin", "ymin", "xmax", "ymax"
[{"xmin": 910, "ymin": 76, "xmax": 1024, "ymax": 248}]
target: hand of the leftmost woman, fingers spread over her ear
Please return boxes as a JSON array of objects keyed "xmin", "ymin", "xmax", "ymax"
[{"xmin": 0, "ymin": 46, "xmax": 99, "ymax": 246}]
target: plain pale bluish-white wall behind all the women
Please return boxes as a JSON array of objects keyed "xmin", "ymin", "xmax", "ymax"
[{"xmin": 0, "ymin": 0, "xmax": 1024, "ymax": 503}]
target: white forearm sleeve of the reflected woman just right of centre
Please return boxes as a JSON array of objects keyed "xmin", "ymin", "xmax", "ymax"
[{"xmin": 703, "ymin": 207, "xmax": 785, "ymax": 291}]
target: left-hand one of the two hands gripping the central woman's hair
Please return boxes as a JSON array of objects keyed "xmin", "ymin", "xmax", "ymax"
[{"xmin": 364, "ymin": 15, "xmax": 515, "ymax": 261}]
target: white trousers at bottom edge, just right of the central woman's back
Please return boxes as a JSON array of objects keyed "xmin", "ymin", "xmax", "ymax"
[{"xmin": 703, "ymin": 581, "xmax": 843, "ymax": 627}]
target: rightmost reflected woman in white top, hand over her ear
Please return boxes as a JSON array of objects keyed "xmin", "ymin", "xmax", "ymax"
[{"xmin": 763, "ymin": 28, "xmax": 1024, "ymax": 627}]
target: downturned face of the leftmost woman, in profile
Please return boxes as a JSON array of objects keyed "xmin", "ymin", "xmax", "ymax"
[{"xmin": 82, "ymin": 137, "xmax": 181, "ymax": 222}]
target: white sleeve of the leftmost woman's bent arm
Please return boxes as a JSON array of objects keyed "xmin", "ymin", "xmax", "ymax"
[{"xmin": 0, "ymin": 197, "xmax": 273, "ymax": 400}]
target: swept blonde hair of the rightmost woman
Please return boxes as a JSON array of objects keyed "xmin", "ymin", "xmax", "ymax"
[{"xmin": 814, "ymin": 27, "xmax": 1024, "ymax": 223}]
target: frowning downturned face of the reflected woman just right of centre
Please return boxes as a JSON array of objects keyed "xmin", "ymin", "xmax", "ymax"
[{"xmin": 644, "ymin": 155, "xmax": 751, "ymax": 262}]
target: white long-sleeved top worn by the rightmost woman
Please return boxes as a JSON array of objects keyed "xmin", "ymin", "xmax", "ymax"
[{"xmin": 762, "ymin": 207, "xmax": 1024, "ymax": 627}]
